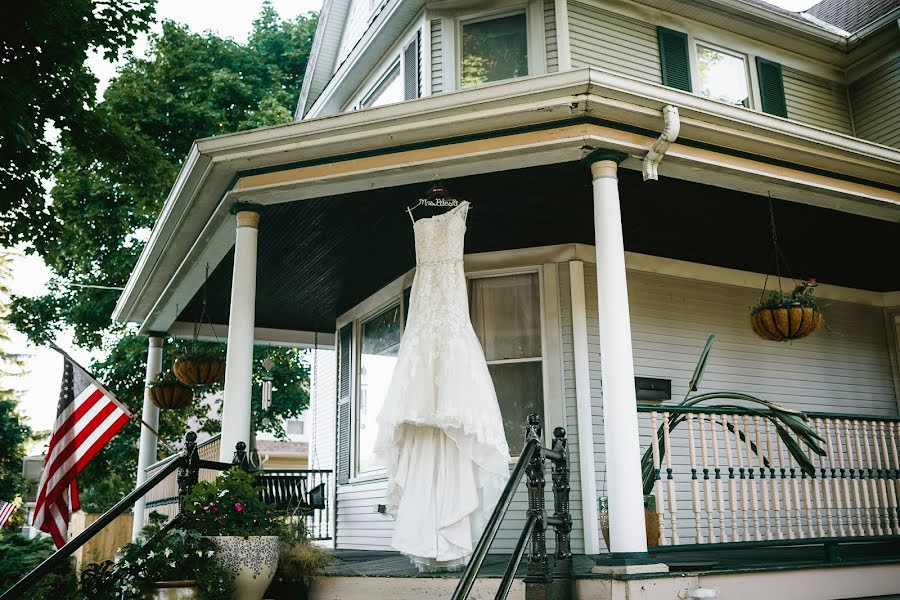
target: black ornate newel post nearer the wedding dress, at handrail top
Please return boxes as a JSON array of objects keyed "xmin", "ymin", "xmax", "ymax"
[{"xmin": 525, "ymin": 414, "xmax": 551, "ymax": 600}]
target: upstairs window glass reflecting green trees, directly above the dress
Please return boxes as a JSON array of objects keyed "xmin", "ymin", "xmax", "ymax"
[{"xmin": 460, "ymin": 12, "xmax": 528, "ymax": 87}]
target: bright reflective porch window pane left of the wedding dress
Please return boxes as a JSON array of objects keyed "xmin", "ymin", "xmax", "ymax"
[{"xmin": 356, "ymin": 304, "xmax": 401, "ymax": 473}]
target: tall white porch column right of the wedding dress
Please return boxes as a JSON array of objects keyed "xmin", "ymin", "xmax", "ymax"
[{"xmin": 591, "ymin": 152, "xmax": 647, "ymax": 554}]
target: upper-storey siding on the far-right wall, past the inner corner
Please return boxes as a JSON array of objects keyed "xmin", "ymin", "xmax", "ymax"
[{"xmin": 850, "ymin": 57, "xmax": 900, "ymax": 148}]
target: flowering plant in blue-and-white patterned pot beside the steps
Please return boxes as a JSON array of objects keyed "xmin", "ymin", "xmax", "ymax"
[{"xmin": 184, "ymin": 467, "xmax": 286, "ymax": 600}]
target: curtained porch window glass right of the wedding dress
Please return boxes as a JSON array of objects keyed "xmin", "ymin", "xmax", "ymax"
[{"xmin": 469, "ymin": 273, "xmax": 544, "ymax": 455}]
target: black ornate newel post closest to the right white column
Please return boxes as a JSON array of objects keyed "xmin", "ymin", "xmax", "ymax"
[{"xmin": 550, "ymin": 427, "xmax": 575, "ymax": 598}]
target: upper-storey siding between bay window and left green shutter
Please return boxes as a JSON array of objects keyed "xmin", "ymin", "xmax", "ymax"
[{"xmin": 569, "ymin": 2, "xmax": 662, "ymax": 83}]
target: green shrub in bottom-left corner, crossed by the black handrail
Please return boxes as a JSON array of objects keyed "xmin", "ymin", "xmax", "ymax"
[{"xmin": 0, "ymin": 531, "xmax": 81, "ymax": 600}]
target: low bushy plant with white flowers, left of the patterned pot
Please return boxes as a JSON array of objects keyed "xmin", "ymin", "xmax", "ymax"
[{"xmin": 112, "ymin": 520, "xmax": 233, "ymax": 600}]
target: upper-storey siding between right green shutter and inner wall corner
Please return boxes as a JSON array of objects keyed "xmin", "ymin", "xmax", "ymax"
[{"xmin": 782, "ymin": 67, "xmax": 853, "ymax": 135}]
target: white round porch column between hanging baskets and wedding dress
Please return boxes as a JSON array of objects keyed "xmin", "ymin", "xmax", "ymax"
[{"xmin": 219, "ymin": 205, "xmax": 259, "ymax": 463}]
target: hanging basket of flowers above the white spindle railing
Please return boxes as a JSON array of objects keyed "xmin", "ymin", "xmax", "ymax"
[{"xmin": 750, "ymin": 279, "xmax": 822, "ymax": 342}]
